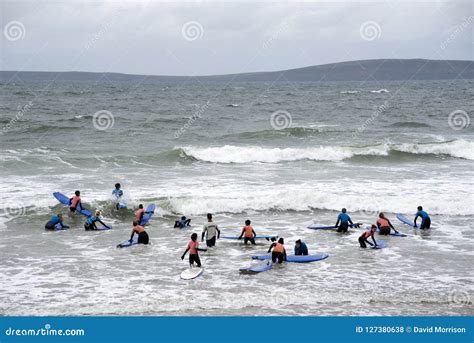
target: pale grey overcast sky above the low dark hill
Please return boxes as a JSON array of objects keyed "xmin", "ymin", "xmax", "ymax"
[{"xmin": 0, "ymin": 0, "xmax": 474, "ymax": 75}]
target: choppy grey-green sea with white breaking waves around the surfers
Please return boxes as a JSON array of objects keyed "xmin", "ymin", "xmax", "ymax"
[{"xmin": 0, "ymin": 80, "xmax": 474, "ymax": 315}]
